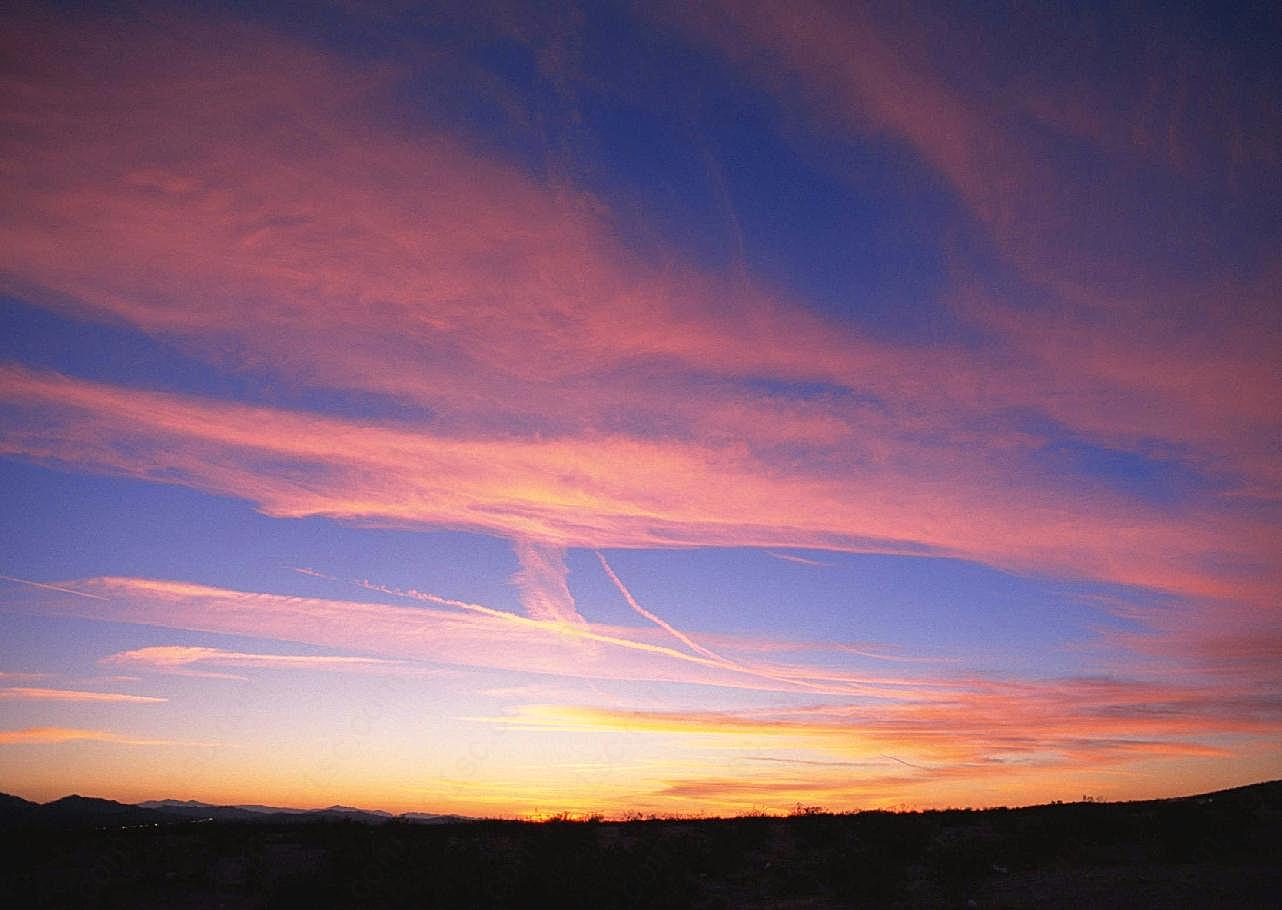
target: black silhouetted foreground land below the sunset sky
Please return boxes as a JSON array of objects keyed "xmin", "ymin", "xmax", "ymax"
[{"xmin": 0, "ymin": 782, "xmax": 1282, "ymax": 909}]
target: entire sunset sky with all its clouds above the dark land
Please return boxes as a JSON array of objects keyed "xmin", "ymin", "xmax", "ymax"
[{"xmin": 0, "ymin": 0, "xmax": 1282, "ymax": 818}]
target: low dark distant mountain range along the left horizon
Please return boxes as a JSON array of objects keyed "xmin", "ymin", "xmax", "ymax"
[{"xmin": 0, "ymin": 793, "xmax": 476, "ymax": 828}]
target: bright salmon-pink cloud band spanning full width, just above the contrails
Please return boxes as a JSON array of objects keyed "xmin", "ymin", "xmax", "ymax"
[{"xmin": 0, "ymin": 367, "xmax": 1277, "ymax": 596}]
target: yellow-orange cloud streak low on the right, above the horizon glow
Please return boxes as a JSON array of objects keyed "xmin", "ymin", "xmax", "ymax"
[{"xmin": 477, "ymin": 697, "xmax": 1261, "ymax": 777}]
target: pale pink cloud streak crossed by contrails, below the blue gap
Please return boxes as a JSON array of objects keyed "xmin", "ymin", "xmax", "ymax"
[{"xmin": 8, "ymin": 578, "xmax": 1092, "ymax": 701}]
